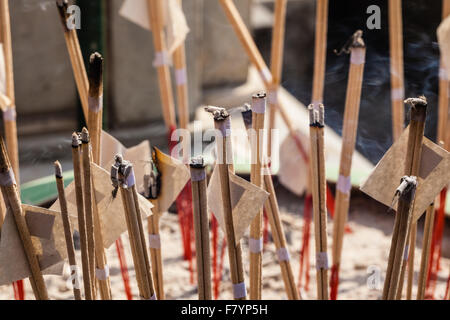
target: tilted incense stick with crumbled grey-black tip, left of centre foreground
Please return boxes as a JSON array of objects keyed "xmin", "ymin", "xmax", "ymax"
[{"xmin": 111, "ymin": 155, "xmax": 156, "ymax": 300}]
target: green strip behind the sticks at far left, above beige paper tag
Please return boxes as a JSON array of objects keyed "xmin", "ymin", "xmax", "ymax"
[{"xmin": 20, "ymin": 171, "xmax": 73, "ymax": 205}]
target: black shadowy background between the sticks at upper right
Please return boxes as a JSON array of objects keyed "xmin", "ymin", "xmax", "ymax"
[{"xmin": 255, "ymin": 0, "xmax": 442, "ymax": 163}]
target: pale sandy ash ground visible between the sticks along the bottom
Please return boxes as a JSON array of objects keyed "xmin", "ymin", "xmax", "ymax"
[{"xmin": 0, "ymin": 184, "xmax": 450, "ymax": 300}]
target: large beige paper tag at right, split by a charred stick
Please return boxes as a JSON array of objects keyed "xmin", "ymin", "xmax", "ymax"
[{"xmin": 360, "ymin": 127, "xmax": 450, "ymax": 220}]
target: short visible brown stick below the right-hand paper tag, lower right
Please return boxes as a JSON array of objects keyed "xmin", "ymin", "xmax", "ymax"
[{"xmin": 417, "ymin": 203, "xmax": 435, "ymax": 300}]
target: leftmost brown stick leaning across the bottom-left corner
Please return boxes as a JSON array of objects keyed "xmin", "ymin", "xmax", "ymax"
[{"xmin": 0, "ymin": 138, "xmax": 48, "ymax": 300}]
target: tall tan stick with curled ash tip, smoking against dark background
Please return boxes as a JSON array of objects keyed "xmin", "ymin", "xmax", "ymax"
[{"xmin": 332, "ymin": 31, "xmax": 366, "ymax": 298}]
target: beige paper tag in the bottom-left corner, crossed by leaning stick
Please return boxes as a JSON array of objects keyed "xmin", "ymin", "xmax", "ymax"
[{"xmin": 0, "ymin": 205, "xmax": 67, "ymax": 285}]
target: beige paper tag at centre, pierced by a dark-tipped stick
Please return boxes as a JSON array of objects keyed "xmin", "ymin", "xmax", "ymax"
[{"xmin": 208, "ymin": 166, "xmax": 269, "ymax": 242}]
